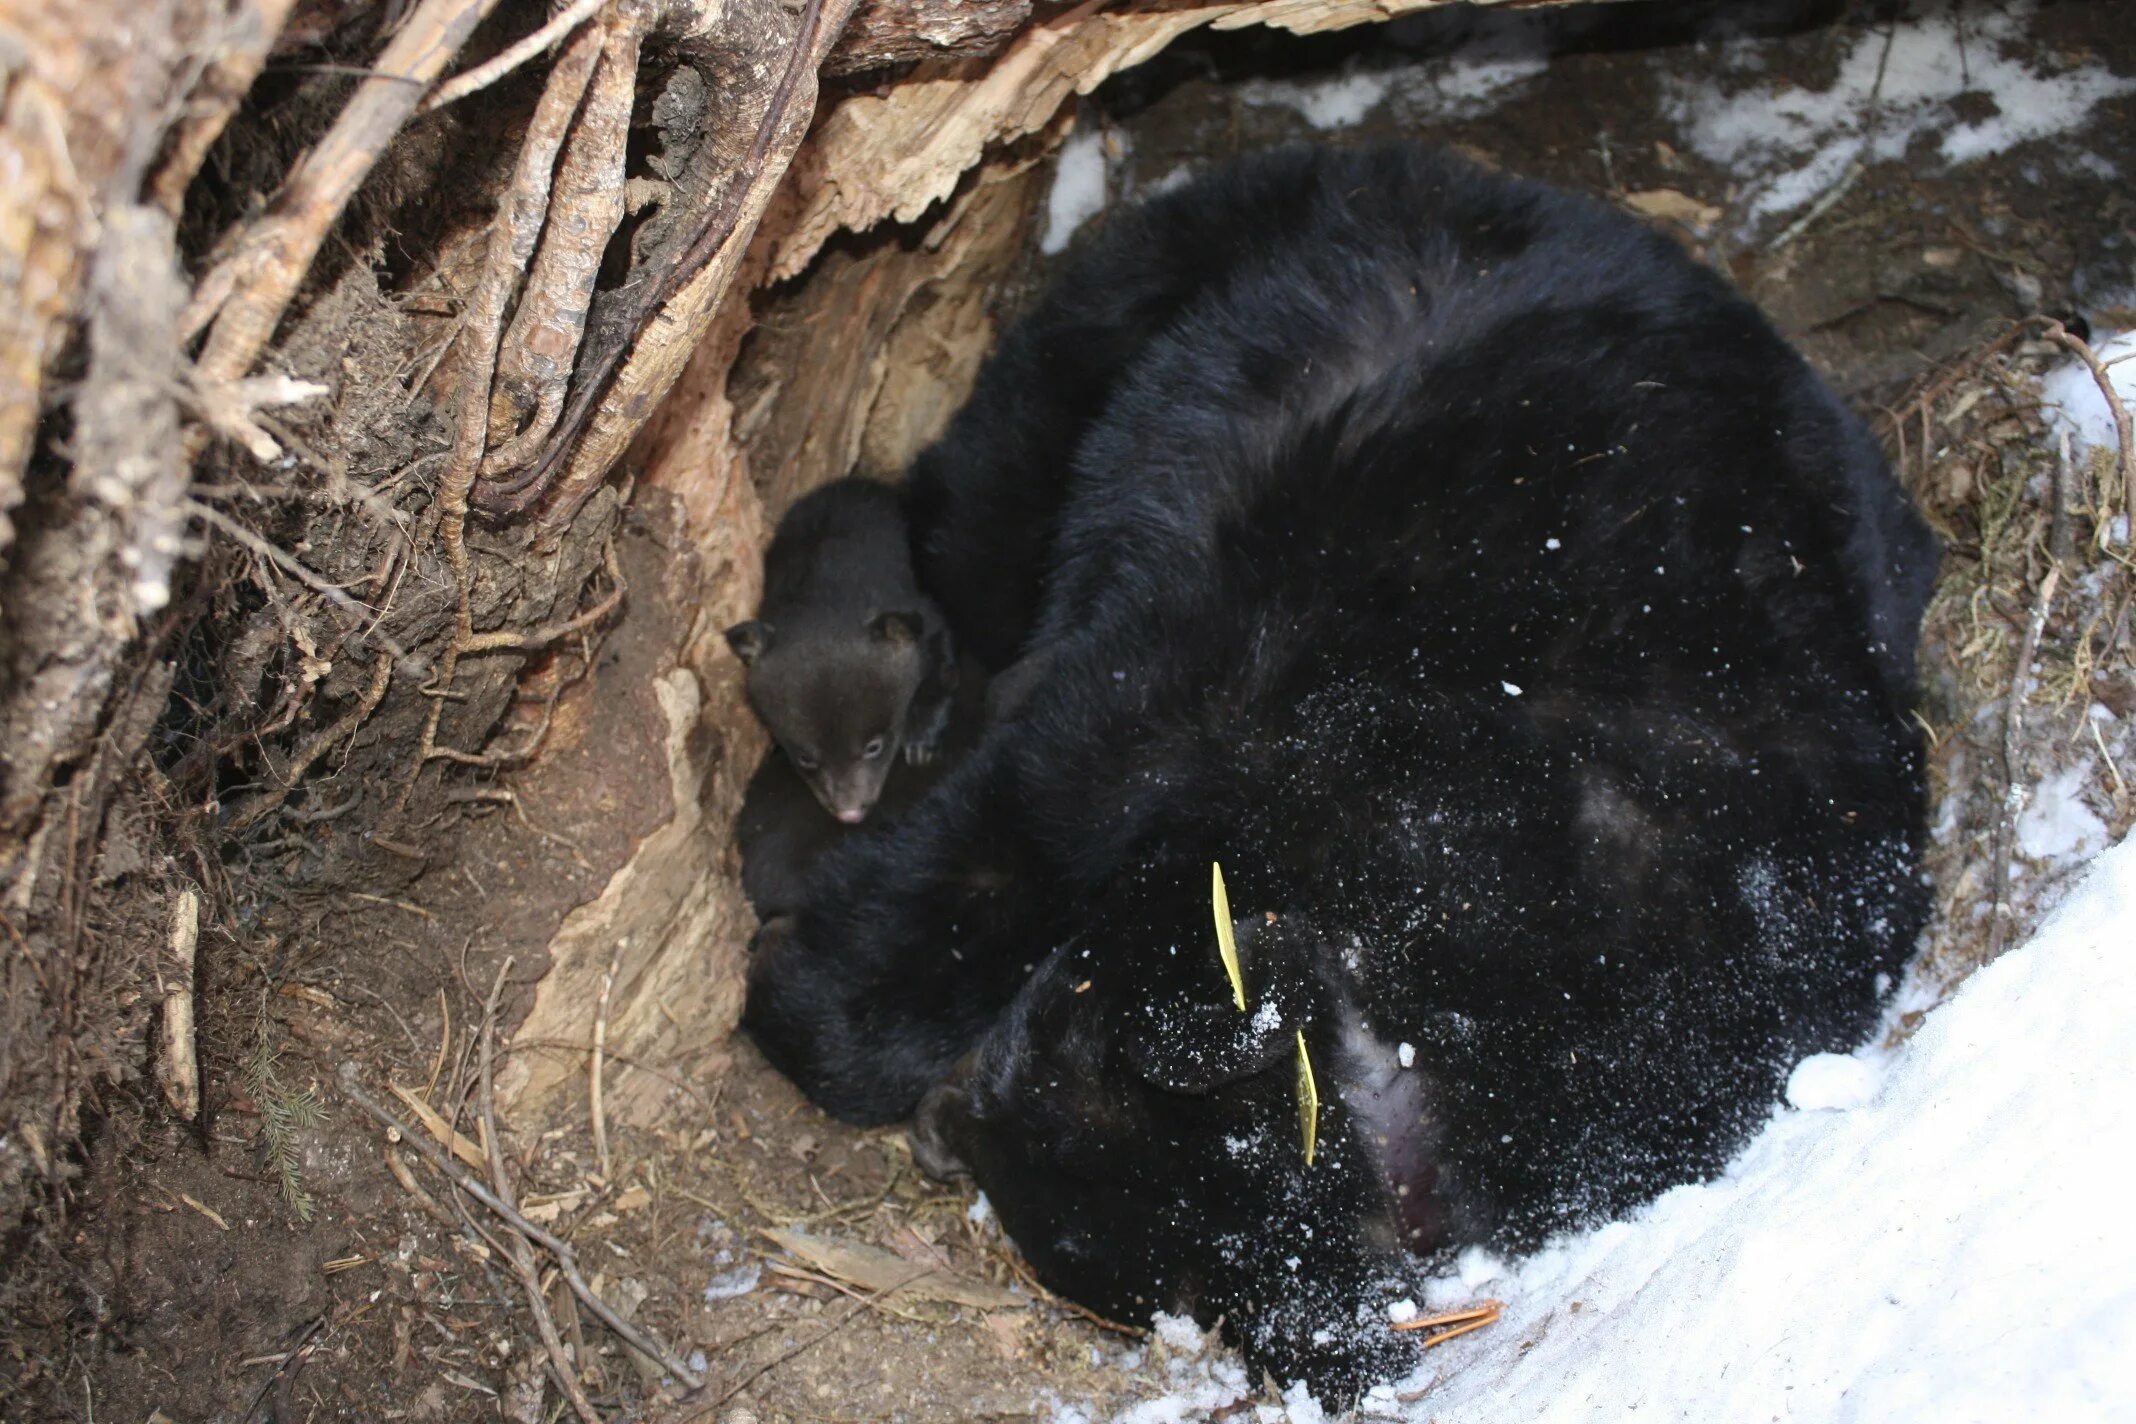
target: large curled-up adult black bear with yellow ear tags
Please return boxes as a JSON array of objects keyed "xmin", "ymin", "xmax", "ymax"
[{"xmin": 748, "ymin": 149, "xmax": 1935, "ymax": 1396}]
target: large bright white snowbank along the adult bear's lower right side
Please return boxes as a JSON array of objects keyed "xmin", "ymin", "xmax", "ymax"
[{"xmin": 1076, "ymin": 841, "xmax": 2136, "ymax": 1424}]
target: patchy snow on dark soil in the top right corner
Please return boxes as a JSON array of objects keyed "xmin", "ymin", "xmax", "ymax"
[{"xmin": 1662, "ymin": 0, "xmax": 2136, "ymax": 216}]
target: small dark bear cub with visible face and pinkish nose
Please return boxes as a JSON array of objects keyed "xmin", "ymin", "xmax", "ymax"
[{"xmin": 726, "ymin": 478, "xmax": 957, "ymax": 822}]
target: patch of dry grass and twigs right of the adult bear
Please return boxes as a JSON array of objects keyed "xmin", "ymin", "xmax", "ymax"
[{"xmin": 1882, "ymin": 329, "xmax": 2136, "ymax": 1011}]
